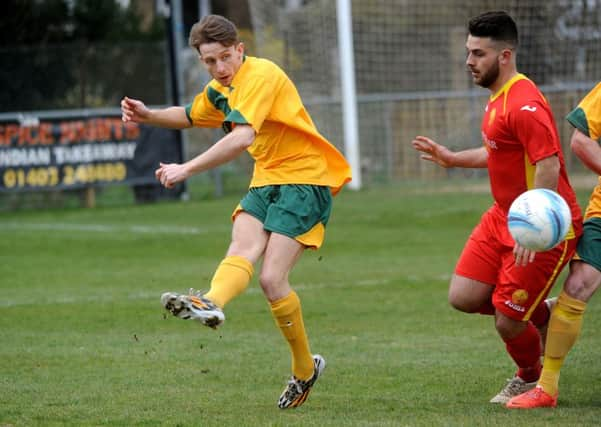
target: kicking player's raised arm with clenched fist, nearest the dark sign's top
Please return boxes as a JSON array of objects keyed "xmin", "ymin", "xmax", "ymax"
[{"xmin": 121, "ymin": 96, "xmax": 191, "ymax": 129}]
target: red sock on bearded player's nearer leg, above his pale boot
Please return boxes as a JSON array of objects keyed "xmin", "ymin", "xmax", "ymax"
[{"xmin": 504, "ymin": 322, "xmax": 542, "ymax": 383}]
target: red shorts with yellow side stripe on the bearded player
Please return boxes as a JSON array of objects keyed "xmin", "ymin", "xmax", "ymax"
[{"xmin": 455, "ymin": 205, "xmax": 578, "ymax": 320}]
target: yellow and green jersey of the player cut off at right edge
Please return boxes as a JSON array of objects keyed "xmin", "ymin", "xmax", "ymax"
[{"xmin": 567, "ymin": 83, "xmax": 601, "ymax": 220}]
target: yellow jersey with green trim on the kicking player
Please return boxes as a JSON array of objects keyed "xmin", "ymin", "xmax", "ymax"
[{"xmin": 186, "ymin": 56, "xmax": 351, "ymax": 194}]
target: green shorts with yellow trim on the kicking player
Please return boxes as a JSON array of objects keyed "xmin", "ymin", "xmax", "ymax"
[{"xmin": 233, "ymin": 184, "xmax": 332, "ymax": 248}]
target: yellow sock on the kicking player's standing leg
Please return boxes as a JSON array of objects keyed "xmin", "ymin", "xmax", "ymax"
[{"xmin": 271, "ymin": 291, "xmax": 315, "ymax": 380}]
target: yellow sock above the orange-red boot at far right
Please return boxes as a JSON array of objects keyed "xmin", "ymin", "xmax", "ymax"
[{"xmin": 538, "ymin": 292, "xmax": 586, "ymax": 396}]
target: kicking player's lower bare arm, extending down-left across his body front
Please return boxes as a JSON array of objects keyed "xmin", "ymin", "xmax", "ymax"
[{"xmin": 155, "ymin": 125, "xmax": 255, "ymax": 188}]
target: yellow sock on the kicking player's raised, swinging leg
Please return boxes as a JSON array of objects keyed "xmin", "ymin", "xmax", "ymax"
[{"xmin": 204, "ymin": 256, "xmax": 253, "ymax": 308}]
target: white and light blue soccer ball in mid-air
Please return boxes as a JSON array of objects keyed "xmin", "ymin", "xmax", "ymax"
[{"xmin": 507, "ymin": 188, "xmax": 572, "ymax": 252}]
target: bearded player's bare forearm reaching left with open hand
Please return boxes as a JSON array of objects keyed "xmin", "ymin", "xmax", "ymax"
[{"xmin": 411, "ymin": 136, "xmax": 488, "ymax": 168}]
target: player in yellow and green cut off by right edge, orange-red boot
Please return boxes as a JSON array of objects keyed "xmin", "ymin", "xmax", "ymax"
[{"xmin": 507, "ymin": 83, "xmax": 601, "ymax": 409}]
